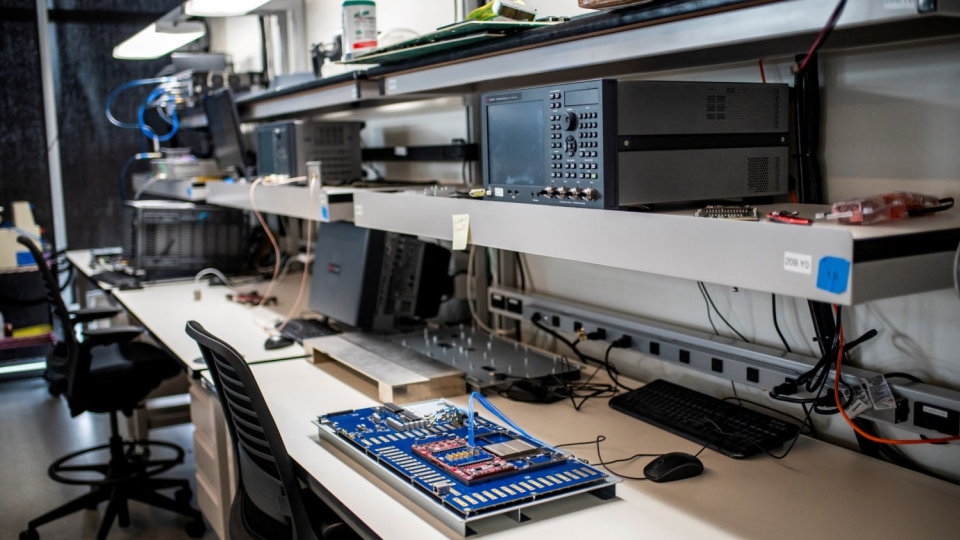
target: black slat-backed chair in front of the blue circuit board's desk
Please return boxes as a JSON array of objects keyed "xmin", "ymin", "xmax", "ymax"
[{"xmin": 186, "ymin": 321, "xmax": 359, "ymax": 540}]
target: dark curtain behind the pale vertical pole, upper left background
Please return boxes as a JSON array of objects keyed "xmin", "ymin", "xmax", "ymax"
[{"xmin": 0, "ymin": 0, "xmax": 187, "ymax": 249}]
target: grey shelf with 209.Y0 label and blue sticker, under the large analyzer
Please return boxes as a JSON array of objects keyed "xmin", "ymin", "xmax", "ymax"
[{"xmin": 354, "ymin": 190, "xmax": 960, "ymax": 305}]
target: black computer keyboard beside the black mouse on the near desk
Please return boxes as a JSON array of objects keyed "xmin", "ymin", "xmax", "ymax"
[{"xmin": 610, "ymin": 380, "xmax": 800, "ymax": 459}]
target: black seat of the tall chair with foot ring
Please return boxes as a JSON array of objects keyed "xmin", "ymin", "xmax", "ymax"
[{"xmin": 83, "ymin": 341, "xmax": 180, "ymax": 413}]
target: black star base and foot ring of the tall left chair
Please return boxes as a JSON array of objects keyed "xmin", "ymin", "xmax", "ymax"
[{"xmin": 20, "ymin": 412, "xmax": 207, "ymax": 540}]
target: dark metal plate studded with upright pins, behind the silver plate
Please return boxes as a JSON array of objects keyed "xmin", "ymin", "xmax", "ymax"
[{"xmin": 391, "ymin": 325, "xmax": 580, "ymax": 389}]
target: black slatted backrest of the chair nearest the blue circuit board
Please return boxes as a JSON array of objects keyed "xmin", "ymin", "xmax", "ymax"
[{"xmin": 186, "ymin": 321, "xmax": 316, "ymax": 540}]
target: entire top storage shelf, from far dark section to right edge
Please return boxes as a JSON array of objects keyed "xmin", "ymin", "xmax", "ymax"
[{"xmin": 232, "ymin": 0, "xmax": 960, "ymax": 121}]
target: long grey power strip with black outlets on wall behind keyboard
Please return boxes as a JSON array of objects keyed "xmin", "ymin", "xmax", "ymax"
[{"xmin": 487, "ymin": 287, "xmax": 960, "ymax": 437}]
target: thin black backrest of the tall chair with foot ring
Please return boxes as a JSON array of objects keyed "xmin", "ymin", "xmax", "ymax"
[{"xmin": 17, "ymin": 236, "xmax": 86, "ymax": 392}]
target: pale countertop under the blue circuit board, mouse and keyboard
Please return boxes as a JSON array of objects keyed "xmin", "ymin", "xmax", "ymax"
[{"xmin": 252, "ymin": 361, "xmax": 960, "ymax": 540}]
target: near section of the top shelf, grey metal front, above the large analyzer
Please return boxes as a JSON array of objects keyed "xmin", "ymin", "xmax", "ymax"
[{"xmin": 378, "ymin": 0, "xmax": 960, "ymax": 96}]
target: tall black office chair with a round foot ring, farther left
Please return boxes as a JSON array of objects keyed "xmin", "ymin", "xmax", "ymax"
[{"xmin": 17, "ymin": 236, "xmax": 206, "ymax": 540}]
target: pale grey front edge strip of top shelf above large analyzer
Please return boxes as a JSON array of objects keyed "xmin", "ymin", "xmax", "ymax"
[{"xmin": 383, "ymin": 0, "xmax": 960, "ymax": 96}]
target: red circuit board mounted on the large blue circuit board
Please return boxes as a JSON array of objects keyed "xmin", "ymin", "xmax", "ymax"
[{"xmin": 410, "ymin": 437, "xmax": 517, "ymax": 485}]
